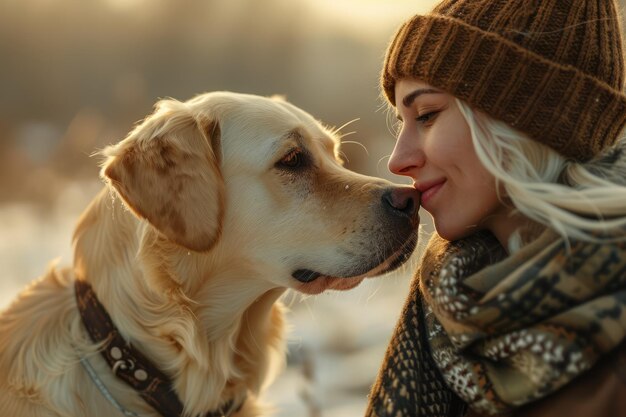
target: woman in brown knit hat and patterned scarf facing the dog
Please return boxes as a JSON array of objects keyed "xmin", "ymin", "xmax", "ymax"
[{"xmin": 367, "ymin": 0, "xmax": 626, "ymax": 417}]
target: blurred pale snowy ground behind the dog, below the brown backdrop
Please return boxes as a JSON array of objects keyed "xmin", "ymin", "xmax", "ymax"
[{"xmin": 0, "ymin": 182, "xmax": 420, "ymax": 417}]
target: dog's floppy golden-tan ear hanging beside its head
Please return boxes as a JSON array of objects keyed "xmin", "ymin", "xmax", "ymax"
[{"xmin": 101, "ymin": 100, "xmax": 224, "ymax": 251}]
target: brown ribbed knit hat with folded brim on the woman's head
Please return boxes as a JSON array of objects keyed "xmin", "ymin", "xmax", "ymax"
[{"xmin": 381, "ymin": 0, "xmax": 626, "ymax": 161}]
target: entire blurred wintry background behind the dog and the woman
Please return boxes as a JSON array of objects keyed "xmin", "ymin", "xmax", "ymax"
[{"xmin": 0, "ymin": 0, "xmax": 624, "ymax": 417}]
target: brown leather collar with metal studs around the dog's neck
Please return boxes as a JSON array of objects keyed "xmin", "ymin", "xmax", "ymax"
[{"xmin": 74, "ymin": 280, "xmax": 239, "ymax": 417}]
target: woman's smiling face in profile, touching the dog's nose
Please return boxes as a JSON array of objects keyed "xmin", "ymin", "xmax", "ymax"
[{"xmin": 389, "ymin": 79, "xmax": 513, "ymax": 247}]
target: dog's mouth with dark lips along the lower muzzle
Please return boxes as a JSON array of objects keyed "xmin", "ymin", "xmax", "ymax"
[{"xmin": 291, "ymin": 233, "xmax": 417, "ymax": 294}]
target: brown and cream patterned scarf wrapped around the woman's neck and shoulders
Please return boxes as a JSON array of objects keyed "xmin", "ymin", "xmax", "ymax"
[{"xmin": 366, "ymin": 232, "xmax": 626, "ymax": 417}]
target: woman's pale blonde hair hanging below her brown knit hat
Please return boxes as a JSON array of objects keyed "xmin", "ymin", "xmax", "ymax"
[{"xmin": 456, "ymin": 99, "xmax": 626, "ymax": 251}]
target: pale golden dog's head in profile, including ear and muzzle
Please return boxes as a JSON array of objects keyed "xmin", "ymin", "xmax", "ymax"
[{"xmin": 102, "ymin": 92, "xmax": 419, "ymax": 293}]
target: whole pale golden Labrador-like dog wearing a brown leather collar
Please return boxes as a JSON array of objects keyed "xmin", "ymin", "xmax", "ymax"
[{"xmin": 0, "ymin": 92, "xmax": 419, "ymax": 417}]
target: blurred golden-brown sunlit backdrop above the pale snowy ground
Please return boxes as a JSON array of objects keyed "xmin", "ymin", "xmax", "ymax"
[{"xmin": 0, "ymin": 0, "xmax": 438, "ymax": 202}]
